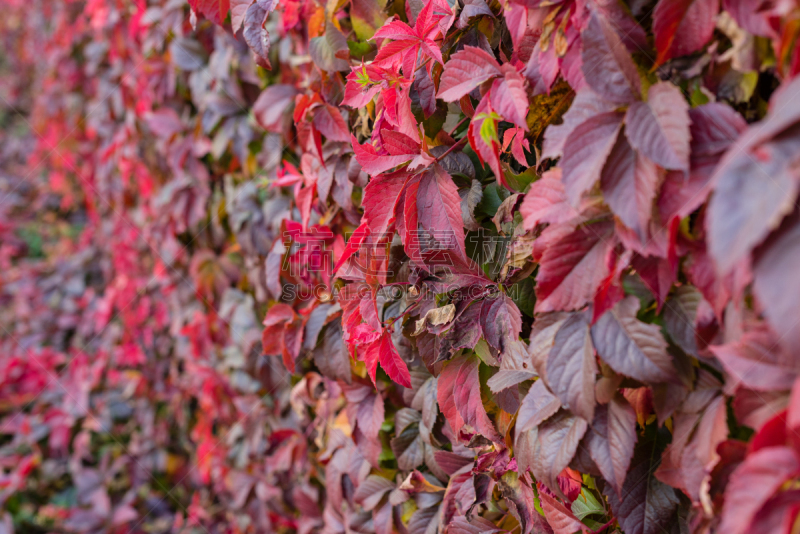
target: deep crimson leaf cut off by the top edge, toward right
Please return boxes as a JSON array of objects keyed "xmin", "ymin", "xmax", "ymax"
[{"xmin": 653, "ymin": 0, "xmax": 719, "ymax": 66}]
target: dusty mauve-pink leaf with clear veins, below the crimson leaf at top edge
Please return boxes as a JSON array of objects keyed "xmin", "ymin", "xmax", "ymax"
[{"xmin": 625, "ymin": 82, "xmax": 690, "ymax": 171}]
